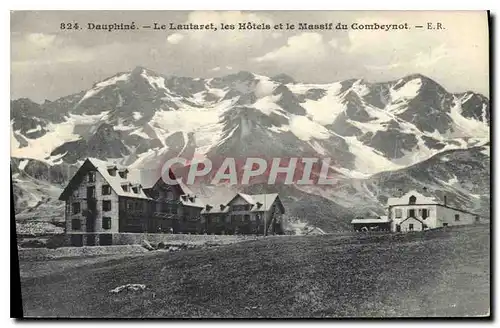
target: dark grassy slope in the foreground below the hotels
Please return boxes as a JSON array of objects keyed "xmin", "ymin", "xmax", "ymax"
[{"xmin": 18, "ymin": 226, "xmax": 490, "ymax": 317}]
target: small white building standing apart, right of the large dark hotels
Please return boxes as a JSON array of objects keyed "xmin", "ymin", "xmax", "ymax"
[{"xmin": 387, "ymin": 191, "xmax": 480, "ymax": 232}]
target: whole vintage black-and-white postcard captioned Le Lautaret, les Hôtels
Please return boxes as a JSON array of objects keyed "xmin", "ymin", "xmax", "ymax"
[{"xmin": 10, "ymin": 11, "xmax": 491, "ymax": 319}]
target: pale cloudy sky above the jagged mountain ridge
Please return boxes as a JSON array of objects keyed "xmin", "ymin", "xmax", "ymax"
[{"xmin": 11, "ymin": 11, "xmax": 489, "ymax": 102}]
